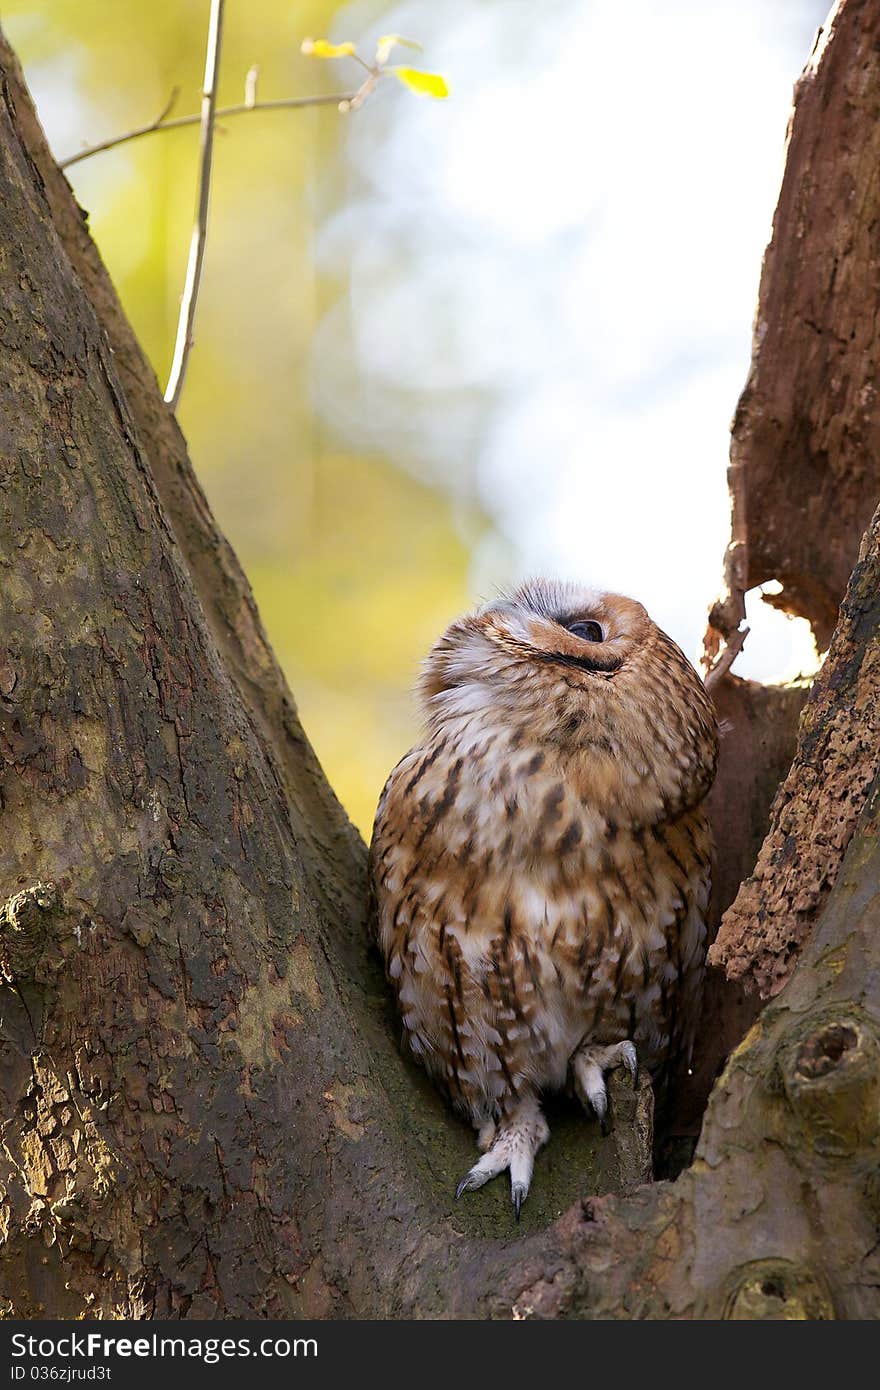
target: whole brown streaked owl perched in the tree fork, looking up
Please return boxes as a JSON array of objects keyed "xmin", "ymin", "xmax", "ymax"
[{"xmin": 370, "ymin": 580, "xmax": 717, "ymax": 1218}]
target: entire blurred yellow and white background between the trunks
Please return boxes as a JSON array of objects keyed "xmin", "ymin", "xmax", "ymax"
[{"xmin": 3, "ymin": 0, "xmax": 824, "ymax": 835}]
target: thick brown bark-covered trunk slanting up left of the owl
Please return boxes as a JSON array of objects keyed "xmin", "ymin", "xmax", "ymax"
[{"xmin": 0, "ymin": 27, "xmax": 658, "ymax": 1316}]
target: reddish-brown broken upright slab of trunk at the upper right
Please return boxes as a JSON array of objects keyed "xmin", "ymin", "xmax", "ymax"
[{"xmin": 712, "ymin": 0, "xmax": 880, "ymax": 651}]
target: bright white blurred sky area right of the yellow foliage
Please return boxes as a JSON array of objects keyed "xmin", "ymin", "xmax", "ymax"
[{"xmin": 314, "ymin": 0, "xmax": 827, "ymax": 680}]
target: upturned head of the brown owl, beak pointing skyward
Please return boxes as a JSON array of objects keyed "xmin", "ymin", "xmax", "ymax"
[{"xmin": 420, "ymin": 578, "xmax": 717, "ymax": 815}]
